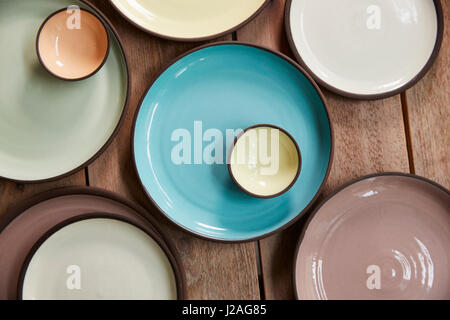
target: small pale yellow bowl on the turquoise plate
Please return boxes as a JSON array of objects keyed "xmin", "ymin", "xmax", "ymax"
[{"xmin": 228, "ymin": 124, "xmax": 301, "ymax": 199}]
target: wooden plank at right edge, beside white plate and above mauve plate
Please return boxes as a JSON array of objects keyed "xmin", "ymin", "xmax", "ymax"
[{"xmin": 406, "ymin": 0, "xmax": 450, "ymax": 188}]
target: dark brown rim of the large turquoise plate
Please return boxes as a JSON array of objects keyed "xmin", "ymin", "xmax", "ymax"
[{"xmin": 130, "ymin": 41, "xmax": 335, "ymax": 243}]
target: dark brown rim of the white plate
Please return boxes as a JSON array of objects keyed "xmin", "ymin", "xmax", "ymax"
[{"xmin": 284, "ymin": 0, "xmax": 445, "ymax": 100}]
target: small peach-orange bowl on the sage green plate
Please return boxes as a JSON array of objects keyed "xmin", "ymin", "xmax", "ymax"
[{"xmin": 36, "ymin": 8, "xmax": 110, "ymax": 81}]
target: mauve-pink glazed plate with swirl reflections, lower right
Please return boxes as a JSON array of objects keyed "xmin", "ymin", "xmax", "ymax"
[{"xmin": 294, "ymin": 174, "xmax": 450, "ymax": 300}]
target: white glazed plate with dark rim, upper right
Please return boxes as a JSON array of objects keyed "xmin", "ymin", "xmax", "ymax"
[{"xmin": 286, "ymin": 0, "xmax": 443, "ymax": 99}]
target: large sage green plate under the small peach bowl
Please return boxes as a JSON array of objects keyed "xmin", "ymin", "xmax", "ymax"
[{"xmin": 0, "ymin": 0, "xmax": 128, "ymax": 182}]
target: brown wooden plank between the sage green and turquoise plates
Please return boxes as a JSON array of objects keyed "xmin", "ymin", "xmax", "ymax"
[{"xmin": 89, "ymin": 0, "xmax": 260, "ymax": 299}]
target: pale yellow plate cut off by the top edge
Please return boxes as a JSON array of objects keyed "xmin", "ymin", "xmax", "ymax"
[{"xmin": 110, "ymin": 0, "xmax": 269, "ymax": 41}]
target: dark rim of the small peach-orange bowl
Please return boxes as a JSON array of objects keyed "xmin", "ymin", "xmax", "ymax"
[{"xmin": 36, "ymin": 8, "xmax": 111, "ymax": 82}]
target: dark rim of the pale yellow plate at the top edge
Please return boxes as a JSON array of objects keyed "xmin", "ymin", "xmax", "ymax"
[{"xmin": 109, "ymin": 0, "xmax": 272, "ymax": 42}]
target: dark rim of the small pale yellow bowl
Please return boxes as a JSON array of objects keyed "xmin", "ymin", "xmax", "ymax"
[{"xmin": 227, "ymin": 124, "xmax": 302, "ymax": 199}]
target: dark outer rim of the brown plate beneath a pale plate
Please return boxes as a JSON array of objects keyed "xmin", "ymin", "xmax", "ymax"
[{"xmin": 0, "ymin": 186, "xmax": 187, "ymax": 300}]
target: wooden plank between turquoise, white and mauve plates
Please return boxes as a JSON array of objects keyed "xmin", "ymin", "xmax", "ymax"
[{"xmin": 237, "ymin": 0, "xmax": 409, "ymax": 299}]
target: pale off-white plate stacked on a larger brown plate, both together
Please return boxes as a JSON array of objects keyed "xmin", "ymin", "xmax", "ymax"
[{"xmin": 0, "ymin": 188, "xmax": 185, "ymax": 300}]
